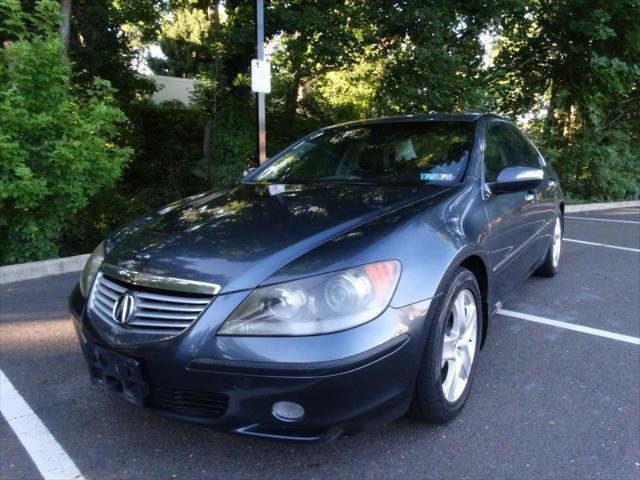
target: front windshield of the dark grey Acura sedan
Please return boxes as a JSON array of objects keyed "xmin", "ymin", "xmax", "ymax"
[{"xmin": 247, "ymin": 121, "xmax": 473, "ymax": 185}]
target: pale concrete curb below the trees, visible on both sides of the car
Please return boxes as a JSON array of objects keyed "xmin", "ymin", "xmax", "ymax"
[{"xmin": 0, "ymin": 200, "xmax": 640, "ymax": 285}]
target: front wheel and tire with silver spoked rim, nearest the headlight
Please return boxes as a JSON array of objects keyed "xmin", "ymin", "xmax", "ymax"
[{"xmin": 412, "ymin": 267, "xmax": 484, "ymax": 423}]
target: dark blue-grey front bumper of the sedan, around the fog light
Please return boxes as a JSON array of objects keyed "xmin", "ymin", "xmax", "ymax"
[{"xmin": 69, "ymin": 288, "xmax": 430, "ymax": 441}]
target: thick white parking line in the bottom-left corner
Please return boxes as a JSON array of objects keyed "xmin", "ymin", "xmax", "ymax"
[{"xmin": 0, "ymin": 370, "xmax": 84, "ymax": 480}]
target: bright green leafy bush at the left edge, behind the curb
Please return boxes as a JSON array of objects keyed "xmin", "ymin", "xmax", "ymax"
[{"xmin": 0, "ymin": 0, "xmax": 132, "ymax": 263}]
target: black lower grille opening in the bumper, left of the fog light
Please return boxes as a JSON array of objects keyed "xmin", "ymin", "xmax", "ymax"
[{"xmin": 146, "ymin": 385, "xmax": 229, "ymax": 418}]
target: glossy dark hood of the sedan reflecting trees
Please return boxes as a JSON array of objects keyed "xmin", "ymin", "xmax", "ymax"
[{"xmin": 105, "ymin": 184, "xmax": 447, "ymax": 293}]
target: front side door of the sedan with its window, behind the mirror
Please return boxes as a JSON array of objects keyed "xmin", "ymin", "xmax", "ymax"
[{"xmin": 483, "ymin": 120, "xmax": 540, "ymax": 299}]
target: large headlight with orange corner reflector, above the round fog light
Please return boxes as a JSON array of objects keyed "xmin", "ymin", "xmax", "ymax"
[{"xmin": 218, "ymin": 260, "xmax": 400, "ymax": 336}]
